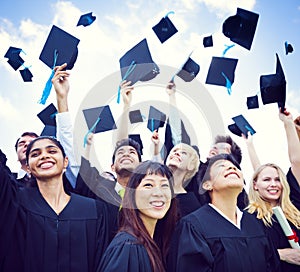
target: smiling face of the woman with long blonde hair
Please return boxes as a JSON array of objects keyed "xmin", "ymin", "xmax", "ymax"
[{"xmin": 253, "ymin": 166, "xmax": 282, "ymax": 207}]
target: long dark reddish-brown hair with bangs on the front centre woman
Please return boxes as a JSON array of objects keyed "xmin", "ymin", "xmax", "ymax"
[{"xmin": 119, "ymin": 161, "xmax": 177, "ymax": 271}]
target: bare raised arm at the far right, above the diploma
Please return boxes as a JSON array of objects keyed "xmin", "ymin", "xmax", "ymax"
[{"xmin": 279, "ymin": 110, "xmax": 300, "ymax": 185}]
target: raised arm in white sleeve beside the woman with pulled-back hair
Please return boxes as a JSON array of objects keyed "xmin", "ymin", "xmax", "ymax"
[{"xmin": 52, "ymin": 64, "xmax": 80, "ymax": 188}]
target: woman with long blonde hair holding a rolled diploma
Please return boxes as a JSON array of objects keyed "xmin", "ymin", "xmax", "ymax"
[{"xmin": 247, "ymin": 163, "xmax": 300, "ymax": 271}]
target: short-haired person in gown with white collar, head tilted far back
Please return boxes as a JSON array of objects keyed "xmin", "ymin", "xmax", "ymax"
[{"xmin": 168, "ymin": 154, "xmax": 279, "ymax": 272}]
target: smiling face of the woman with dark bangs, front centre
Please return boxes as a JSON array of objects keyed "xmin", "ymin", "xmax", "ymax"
[{"xmin": 135, "ymin": 174, "xmax": 172, "ymax": 223}]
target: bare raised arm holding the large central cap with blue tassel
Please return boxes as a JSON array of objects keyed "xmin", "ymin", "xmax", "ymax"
[{"xmin": 116, "ymin": 80, "xmax": 134, "ymax": 142}]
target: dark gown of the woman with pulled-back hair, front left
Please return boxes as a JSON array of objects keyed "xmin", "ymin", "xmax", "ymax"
[{"xmin": 0, "ymin": 150, "xmax": 111, "ymax": 272}]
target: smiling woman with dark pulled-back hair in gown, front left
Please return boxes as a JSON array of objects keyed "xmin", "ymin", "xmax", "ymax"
[{"xmin": 0, "ymin": 136, "xmax": 113, "ymax": 272}]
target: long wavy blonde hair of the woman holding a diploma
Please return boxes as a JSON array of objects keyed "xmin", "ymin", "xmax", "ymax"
[{"xmin": 246, "ymin": 163, "xmax": 300, "ymax": 229}]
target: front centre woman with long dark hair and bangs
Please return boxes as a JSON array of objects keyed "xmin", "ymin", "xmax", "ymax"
[{"xmin": 98, "ymin": 161, "xmax": 177, "ymax": 272}]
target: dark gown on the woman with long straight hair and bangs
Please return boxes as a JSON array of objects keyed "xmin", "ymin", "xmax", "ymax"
[{"xmin": 97, "ymin": 232, "xmax": 153, "ymax": 272}]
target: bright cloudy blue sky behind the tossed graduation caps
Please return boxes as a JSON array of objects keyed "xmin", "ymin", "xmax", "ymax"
[{"xmin": 0, "ymin": 0, "xmax": 300, "ymax": 183}]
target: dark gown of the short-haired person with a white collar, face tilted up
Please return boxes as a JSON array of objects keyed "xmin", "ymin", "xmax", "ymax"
[{"xmin": 168, "ymin": 205, "xmax": 279, "ymax": 272}]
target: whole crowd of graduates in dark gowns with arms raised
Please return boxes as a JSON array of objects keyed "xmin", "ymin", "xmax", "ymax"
[{"xmin": 0, "ymin": 64, "xmax": 300, "ymax": 272}]
